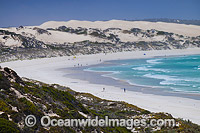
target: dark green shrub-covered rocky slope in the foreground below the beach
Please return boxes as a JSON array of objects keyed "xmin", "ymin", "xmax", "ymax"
[{"xmin": 0, "ymin": 68, "xmax": 200, "ymax": 133}]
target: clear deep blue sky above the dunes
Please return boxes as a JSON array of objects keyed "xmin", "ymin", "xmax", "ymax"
[{"xmin": 0, "ymin": 0, "xmax": 200, "ymax": 27}]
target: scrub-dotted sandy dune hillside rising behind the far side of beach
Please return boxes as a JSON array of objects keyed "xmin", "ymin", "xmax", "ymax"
[{"xmin": 0, "ymin": 20, "xmax": 200, "ymax": 62}]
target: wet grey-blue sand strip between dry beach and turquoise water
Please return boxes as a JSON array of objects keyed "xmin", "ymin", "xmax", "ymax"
[{"xmin": 63, "ymin": 61, "xmax": 200, "ymax": 100}]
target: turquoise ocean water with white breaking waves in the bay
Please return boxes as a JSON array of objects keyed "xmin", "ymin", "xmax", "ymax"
[{"xmin": 87, "ymin": 55, "xmax": 200, "ymax": 93}]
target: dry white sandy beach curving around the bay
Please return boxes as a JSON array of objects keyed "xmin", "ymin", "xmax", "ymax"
[{"xmin": 0, "ymin": 48, "xmax": 200, "ymax": 124}]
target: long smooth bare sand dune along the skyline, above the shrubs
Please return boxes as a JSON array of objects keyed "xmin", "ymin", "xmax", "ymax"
[{"xmin": 40, "ymin": 20, "xmax": 200, "ymax": 36}]
